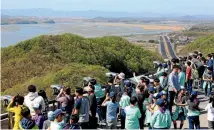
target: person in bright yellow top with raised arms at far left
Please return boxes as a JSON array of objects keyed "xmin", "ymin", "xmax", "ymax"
[{"xmin": 7, "ymin": 95, "xmax": 24, "ymax": 130}]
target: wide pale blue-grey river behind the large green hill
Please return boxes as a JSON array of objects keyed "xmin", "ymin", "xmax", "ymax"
[{"xmin": 1, "ymin": 22, "xmax": 170, "ymax": 47}]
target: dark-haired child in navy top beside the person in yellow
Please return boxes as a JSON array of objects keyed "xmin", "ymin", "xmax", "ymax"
[{"xmin": 19, "ymin": 106, "xmax": 39, "ymax": 130}]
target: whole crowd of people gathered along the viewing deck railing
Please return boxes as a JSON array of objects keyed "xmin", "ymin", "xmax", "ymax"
[{"xmin": 7, "ymin": 52, "xmax": 214, "ymax": 130}]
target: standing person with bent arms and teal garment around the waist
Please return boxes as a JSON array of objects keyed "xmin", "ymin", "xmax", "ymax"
[{"xmin": 172, "ymin": 86, "xmax": 187, "ymax": 129}]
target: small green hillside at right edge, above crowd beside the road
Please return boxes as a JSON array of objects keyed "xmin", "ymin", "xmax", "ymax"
[{"xmin": 181, "ymin": 35, "xmax": 214, "ymax": 55}]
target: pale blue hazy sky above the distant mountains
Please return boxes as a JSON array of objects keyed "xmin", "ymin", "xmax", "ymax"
[{"xmin": 1, "ymin": 0, "xmax": 214, "ymax": 15}]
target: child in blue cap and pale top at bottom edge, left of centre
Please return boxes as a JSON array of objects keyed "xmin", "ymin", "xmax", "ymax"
[{"xmin": 49, "ymin": 109, "xmax": 65, "ymax": 130}]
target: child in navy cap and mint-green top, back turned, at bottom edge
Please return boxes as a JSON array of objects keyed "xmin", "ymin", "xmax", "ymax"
[{"xmin": 151, "ymin": 99, "xmax": 172, "ymax": 129}]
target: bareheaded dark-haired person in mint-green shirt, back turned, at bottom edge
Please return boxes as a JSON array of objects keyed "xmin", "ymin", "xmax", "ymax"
[{"xmin": 124, "ymin": 96, "xmax": 143, "ymax": 130}]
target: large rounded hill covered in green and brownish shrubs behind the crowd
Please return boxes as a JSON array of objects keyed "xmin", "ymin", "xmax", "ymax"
[{"xmin": 1, "ymin": 34, "xmax": 161, "ymax": 96}]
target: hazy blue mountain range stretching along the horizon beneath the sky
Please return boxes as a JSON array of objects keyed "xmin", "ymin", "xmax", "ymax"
[{"xmin": 1, "ymin": 9, "xmax": 214, "ymax": 21}]
